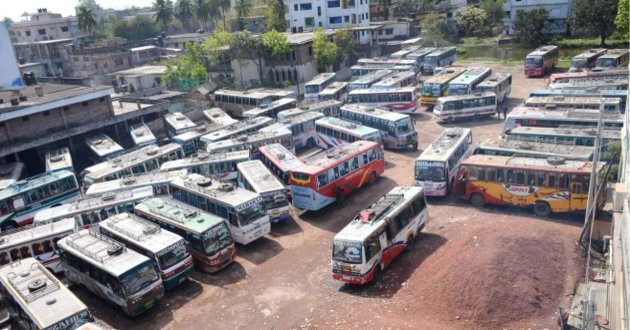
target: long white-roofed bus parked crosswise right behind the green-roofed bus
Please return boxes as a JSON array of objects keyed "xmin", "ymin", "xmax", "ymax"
[{"xmin": 34, "ymin": 187, "xmax": 153, "ymax": 229}]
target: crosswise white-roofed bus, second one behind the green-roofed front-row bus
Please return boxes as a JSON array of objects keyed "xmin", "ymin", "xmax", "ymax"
[{"xmin": 84, "ymin": 170, "xmax": 188, "ymax": 196}]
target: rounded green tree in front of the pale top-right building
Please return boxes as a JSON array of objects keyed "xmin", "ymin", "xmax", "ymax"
[{"xmin": 513, "ymin": 8, "xmax": 549, "ymax": 46}]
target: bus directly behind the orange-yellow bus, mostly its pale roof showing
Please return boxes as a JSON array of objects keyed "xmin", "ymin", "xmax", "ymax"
[{"xmin": 473, "ymin": 138, "xmax": 594, "ymax": 161}]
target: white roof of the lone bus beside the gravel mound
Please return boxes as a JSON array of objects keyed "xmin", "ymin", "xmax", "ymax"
[{"xmin": 334, "ymin": 186, "xmax": 423, "ymax": 242}]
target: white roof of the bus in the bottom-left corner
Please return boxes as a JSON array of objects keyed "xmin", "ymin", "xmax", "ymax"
[{"xmin": 0, "ymin": 258, "xmax": 90, "ymax": 329}]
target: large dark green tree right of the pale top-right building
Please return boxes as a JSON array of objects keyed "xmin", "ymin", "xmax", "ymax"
[{"xmin": 569, "ymin": 0, "xmax": 627, "ymax": 46}]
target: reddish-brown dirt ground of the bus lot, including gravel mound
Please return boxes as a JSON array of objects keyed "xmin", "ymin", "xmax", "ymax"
[{"xmin": 72, "ymin": 64, "xmax": 583, "ymax": 330}]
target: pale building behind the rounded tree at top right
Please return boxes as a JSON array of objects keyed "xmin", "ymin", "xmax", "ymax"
[{"xmin": 503, "ymin": 0, "xmax": 573, "ymax": 35}]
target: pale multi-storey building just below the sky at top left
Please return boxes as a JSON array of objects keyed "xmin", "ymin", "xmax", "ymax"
[{"xmin": 11, "ymin": 8, "xmax": 88, "ymax": 42}]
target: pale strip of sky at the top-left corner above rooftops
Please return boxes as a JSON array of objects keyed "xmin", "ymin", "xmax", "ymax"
[{"xmin": 0, "ymin": 0, "xmax": 154, "ymax": 22}]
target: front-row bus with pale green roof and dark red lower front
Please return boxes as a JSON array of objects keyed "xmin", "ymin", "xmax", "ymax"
[{"xmin": 134, "ymin": 197, "xmax": 236, "ymax": 273}]
